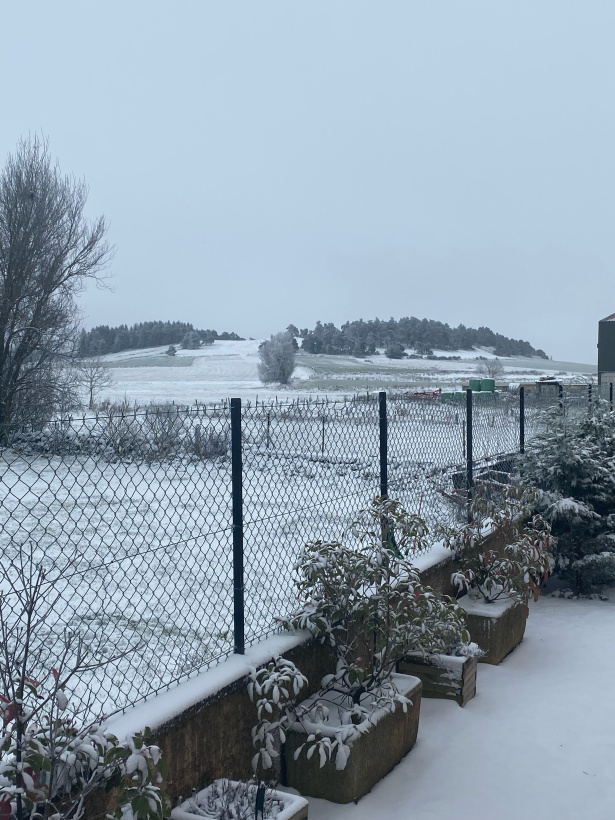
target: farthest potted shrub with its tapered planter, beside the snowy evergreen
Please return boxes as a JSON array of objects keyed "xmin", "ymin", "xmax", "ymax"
[{"xmin": 441, "ymin": 486, "xmax": 554, "ymax": 664}]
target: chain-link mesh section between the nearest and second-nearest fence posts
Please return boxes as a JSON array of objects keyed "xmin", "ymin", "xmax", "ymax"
[{"xmin": 242, "ymin": 396, "xmax": 379, "ymax": 642}]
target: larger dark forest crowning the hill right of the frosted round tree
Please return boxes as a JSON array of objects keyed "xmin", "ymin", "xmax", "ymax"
[{"xmin": 288, "ymin": 316, "xmax": 549, "ymax": 359}]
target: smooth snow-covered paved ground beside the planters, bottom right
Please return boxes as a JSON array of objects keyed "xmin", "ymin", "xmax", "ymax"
[{"xmin": 309, "ymin": 591, "xmax": 615, "ymax": 820}]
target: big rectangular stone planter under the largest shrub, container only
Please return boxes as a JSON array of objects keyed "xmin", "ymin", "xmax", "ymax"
[{"xmin": 284, "ymin": 675, "xmax": 422, "ymax": 803}]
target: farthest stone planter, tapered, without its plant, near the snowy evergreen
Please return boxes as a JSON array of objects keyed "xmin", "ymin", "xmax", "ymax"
[{"xmin": 457, "ymin": 595, "xmax": 527, "ymax": 664}]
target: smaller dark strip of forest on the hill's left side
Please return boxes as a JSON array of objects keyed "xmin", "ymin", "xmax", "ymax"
[{"xmin": 77, "ymin": 322, "xmax": 243, "ymax": 356}]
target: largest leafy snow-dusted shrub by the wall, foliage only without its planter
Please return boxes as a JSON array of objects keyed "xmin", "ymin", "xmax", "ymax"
[{"xmin": 284, "ymin": 498, "xmax": 469, "ymax": 708}]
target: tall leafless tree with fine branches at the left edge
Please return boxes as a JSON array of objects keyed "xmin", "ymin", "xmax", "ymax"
[{"xmin": 0, "ymin": 137, "xmax": 112, "ymax": 441}]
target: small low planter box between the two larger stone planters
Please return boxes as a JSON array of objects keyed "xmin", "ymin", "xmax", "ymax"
[{"xmin": 397, "ymin": 652, "xmax": 478, "ymax": 706}]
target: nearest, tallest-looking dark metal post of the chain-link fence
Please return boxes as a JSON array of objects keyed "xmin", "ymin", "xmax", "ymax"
[{"xmin": 231, "ymin": 399, "xmax": 245, "ymax": 655}]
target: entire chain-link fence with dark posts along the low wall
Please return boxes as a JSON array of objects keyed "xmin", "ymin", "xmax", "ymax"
[{"xmin": 0, "ymin": 385, "xmax": 608, "ymax": 713}]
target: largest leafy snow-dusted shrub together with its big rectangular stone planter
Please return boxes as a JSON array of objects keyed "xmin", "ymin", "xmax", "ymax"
[{"xmin": 276, "ymin": 498, "xmax": 469, "ymax": 803}]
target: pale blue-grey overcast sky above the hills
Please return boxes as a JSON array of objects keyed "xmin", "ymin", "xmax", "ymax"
[{"xmin": 0, "ymin": 0, "xmax": 615, "ymax": 362}]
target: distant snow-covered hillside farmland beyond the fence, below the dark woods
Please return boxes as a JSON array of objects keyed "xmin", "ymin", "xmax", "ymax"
[{"xmin": 99, "ymin": 339, "xmax": 596, "ymax": 405}]
